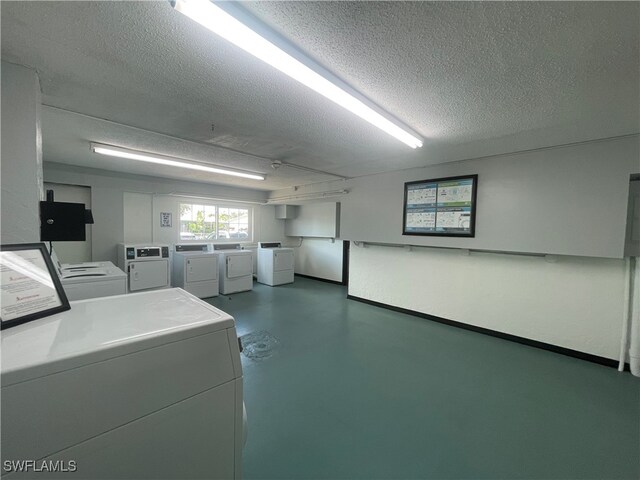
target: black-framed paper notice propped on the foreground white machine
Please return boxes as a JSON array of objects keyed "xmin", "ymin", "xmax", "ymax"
[{"xmin": 0, "ymin": 243, "xmax": 71, "ymax": 329}]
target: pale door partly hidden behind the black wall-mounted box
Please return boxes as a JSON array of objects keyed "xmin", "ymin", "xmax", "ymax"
[{"xmin": 44, "ymin": 183, "xmax": 92, "ymax": 263}]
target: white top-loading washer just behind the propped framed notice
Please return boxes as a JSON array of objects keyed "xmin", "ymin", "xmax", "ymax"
[{"xmin": 58, "ymin": 262, "xmax": 127, "ymax": 300}]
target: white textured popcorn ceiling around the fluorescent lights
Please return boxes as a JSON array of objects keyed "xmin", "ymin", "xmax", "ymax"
[{"xmin": 0, "ymin": 1, "xmax": 640, "ymax": 189}]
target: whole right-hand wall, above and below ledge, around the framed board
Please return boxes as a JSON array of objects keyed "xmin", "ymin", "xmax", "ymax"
[{"xmin": 272, "ymin": 135, "xmax": 640, "ymax": 358}]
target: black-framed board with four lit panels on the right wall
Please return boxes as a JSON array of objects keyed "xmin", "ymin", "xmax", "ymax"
[{"xmin": 402, "ymin": 175, "xmax": 478, "ymax": 237}]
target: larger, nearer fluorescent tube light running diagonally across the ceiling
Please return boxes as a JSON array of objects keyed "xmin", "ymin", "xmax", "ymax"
[{"xmin": 171, "ymin": 0, "xmax": 422, "ymax": 148}]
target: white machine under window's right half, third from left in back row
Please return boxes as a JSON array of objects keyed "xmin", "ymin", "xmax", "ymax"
[{"xmin": 212, "ymin": 243, "xmax": 253, "ymax": 295}]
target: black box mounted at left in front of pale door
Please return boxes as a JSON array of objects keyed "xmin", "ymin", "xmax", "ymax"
[{"xmin": 40, "ymin": 202, "xmax": 87, "ymax": 242}]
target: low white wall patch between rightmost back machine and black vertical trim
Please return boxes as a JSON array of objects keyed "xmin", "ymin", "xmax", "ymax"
[{"xmin": 295, "ymin": 237, "xmax": 342, "ymax": 282}]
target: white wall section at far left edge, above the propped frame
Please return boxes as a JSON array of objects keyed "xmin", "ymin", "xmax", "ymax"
[{"xmin": 0, "ymin": 62, "xmax": 43, "ymax": 243}]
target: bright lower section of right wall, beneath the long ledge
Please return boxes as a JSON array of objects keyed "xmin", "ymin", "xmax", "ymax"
[{"xmin": 349, "ymin": 245, "xmax": 625, "ymax": 359}]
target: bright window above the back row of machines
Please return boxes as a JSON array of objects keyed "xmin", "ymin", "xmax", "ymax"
[{"xmin": 180, "ymin": 203, "xmax": 253, "ymax": 242}]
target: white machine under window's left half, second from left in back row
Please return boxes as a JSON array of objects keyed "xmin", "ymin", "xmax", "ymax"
[{"xmin": 171, "ymin": 244, "xmax": 218, "ymax": 298}]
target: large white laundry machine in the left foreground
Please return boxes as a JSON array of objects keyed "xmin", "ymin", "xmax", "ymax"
[{"xmin": 0, "ymin": 288, "xmax": 246, "ymax": 480}]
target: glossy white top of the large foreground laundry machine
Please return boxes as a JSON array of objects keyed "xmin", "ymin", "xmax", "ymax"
[{"xmin": 0, "ymin": 288, "xmax": 234, "ymax": 386}]
